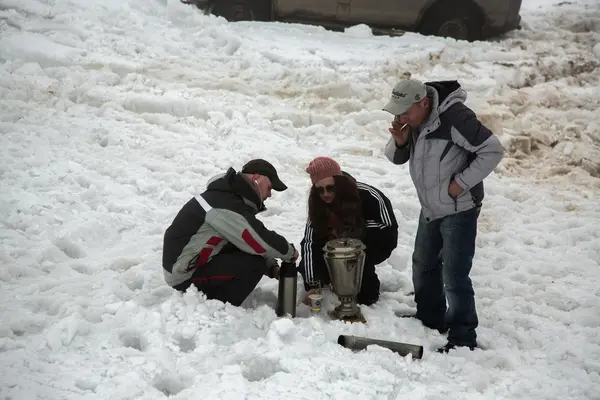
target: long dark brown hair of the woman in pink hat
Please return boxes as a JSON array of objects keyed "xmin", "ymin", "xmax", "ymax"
[{"xmin": 308, "ymin": 175, "xmax": 365, "ymax": 243}]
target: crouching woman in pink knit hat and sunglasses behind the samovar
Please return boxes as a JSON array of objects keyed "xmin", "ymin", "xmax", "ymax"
[{"xmin": 299, "ymin": 157, "xmax": 398, "ymax": 305}]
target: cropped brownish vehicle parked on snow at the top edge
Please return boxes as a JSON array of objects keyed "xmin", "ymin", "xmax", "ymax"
[{"xmin": 181, "ymin": 0, "xmax": 522, "ymax": 40}]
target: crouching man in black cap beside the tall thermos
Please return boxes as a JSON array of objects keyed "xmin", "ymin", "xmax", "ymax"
[{"xmin": 163, "ymin": 159, "xmax": 298, "ymax": 306}]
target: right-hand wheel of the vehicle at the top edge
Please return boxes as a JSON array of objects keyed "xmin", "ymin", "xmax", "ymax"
[{"xmin": 419, "ymin": 0, "xmax": 483, "ymax": 42}]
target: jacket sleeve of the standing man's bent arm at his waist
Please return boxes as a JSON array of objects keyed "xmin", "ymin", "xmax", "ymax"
[{"xmin": 450, "ymin": 103, "xmax": 504, "ymax": 190}]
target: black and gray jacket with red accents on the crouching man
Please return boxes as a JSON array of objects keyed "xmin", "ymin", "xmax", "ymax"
[{"xmin": 162, "ymin": 168, "xmax": 295, "ymax": 286}]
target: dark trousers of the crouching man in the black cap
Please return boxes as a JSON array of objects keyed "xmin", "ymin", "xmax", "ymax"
[{"xmin": 175, "ymin": 250, "xmax": 267, "ymax": 306}]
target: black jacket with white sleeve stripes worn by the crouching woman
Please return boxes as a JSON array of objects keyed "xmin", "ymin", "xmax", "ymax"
[{"xmin": 298, "ymin": 174, "xmax": 398, "ymax": 290}]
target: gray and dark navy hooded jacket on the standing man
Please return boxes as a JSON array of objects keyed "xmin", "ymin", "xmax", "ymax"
[{"xmin": 385, "ymin": 81, "xmax": 504, "ymax": 222}]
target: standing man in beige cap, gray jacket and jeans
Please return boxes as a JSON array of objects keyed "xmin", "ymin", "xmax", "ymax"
[{"xmin": 383, "ymin": 79, "xmax": 504, "ymax": 353}]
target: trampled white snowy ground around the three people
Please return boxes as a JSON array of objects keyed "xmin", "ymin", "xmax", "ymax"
[{"xmin": 0, "ymin": 0, "xmax": 600, "ymax": 400}]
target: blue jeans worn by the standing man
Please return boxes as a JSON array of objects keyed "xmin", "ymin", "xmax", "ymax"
[{"xmin": 413, "ymin": 207, "xmax": 481, "ymax": 347}]
